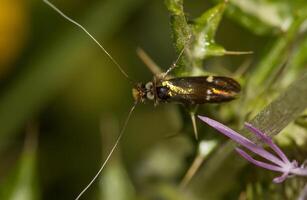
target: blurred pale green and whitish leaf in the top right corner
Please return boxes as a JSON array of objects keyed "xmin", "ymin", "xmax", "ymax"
[{"xmin": 219, "ymin": 0, "xmax": 306, "ymax": 35}]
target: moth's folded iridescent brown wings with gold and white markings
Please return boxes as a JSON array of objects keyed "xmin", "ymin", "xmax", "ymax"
[{"xmin": 157, "ymin": 76, "xmax": 241, "ymax": 104}]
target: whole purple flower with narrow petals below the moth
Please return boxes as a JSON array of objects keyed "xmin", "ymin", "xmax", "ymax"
[{"xmin": 198, "ymin": 116, "xmax": 307, "ymax": 183}]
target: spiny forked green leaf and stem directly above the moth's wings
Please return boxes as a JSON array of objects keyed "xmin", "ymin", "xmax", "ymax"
[{"xmin": 165, "ymin": 0, "xmax": 231, "ymax": 75}]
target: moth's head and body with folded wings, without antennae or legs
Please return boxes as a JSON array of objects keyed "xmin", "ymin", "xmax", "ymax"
[{"xmin": 132, "ymin": 76, "xmax": 241, "ymax": 105}]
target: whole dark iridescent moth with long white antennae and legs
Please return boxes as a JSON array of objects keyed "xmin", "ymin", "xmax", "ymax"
[{"xmin": 43, "ymin": 0, "xmax": 249, "ymax": 200}]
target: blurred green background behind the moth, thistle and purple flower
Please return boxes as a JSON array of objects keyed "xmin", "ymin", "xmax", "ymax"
[{"xmin": 0, "ymin": 0, "xmax": 307, "ymax": 200}]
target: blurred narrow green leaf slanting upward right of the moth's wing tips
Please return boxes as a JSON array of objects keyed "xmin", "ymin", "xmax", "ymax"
[{"xmin": 242, "ymin": 16, "xmax": 305, "ymax": 117}]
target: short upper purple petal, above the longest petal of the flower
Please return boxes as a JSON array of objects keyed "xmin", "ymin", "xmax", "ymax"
[{"xmin": 244, "ymin": 123, "xmax": 290, "ymax": 164}]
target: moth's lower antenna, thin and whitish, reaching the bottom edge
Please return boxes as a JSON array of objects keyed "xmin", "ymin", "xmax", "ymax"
[{"xmin": 75, "ymin": 102, "xmax": 137, "ymax": 200}]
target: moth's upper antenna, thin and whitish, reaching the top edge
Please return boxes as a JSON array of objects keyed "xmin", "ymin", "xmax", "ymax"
[{"xmin": 43, "ymin": 0, "xmax": 133, "ymax": 82}]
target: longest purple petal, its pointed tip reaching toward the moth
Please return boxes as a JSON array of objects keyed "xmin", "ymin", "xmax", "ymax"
[{"xmin": 198, "ymin": 116, "xmax": 285, "ymax": 166}]
